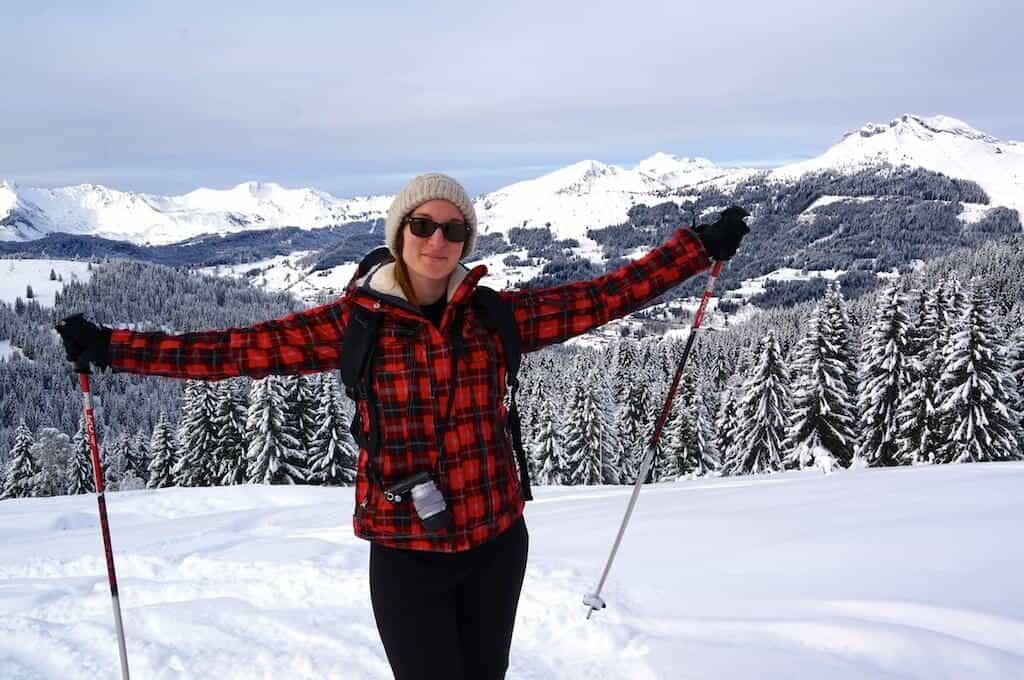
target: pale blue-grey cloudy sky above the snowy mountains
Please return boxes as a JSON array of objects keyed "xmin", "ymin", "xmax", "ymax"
[{"xmin": 0, "ymin": 0, "xmax": 1024, "ymax": 197}]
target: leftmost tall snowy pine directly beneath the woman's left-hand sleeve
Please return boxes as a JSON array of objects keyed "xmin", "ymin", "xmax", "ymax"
[{"xmin": 174, "ymin": 380, "xmax": 219, "ymax": 486}]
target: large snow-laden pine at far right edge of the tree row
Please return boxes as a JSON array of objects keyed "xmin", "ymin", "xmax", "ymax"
[{"xmin": 938, "ymin": 288, "xmax": 1019, "ymax": 463}]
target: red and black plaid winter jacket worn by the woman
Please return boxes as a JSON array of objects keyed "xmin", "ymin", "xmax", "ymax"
[{"xmin": 111, "ymin": 229, "xmax": 711, "ymax": 552}]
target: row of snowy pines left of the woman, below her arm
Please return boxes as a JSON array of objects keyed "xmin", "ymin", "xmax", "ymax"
[{"xmin": 0, "ymin": 373, "xmax": 357, "ymax": 499}]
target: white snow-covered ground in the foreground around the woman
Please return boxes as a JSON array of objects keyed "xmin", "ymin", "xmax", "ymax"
[{"xmin": 0, "ymin": 463, "xmax": 1024, "ymax": 680}]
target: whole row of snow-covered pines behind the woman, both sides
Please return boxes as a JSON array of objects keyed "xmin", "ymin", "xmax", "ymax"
[{"xmin": 2, "ymin": 275, "xmax": 1024, "ymax": 498}]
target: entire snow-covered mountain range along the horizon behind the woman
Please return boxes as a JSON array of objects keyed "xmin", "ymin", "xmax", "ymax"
[{"xmin": 6, "ymin": 115, "xmax": 1024, "ymax": 246}]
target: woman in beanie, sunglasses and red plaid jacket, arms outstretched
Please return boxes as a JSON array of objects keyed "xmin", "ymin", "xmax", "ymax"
[{"xmin": 58, "ymin": 173, "xmax": 748, "ymax": 680}]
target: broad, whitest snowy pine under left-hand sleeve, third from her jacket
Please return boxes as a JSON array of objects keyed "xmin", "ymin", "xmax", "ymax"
[{"xmin": 245, "ymin": 375, "xmax": 305, "ymax": 484}]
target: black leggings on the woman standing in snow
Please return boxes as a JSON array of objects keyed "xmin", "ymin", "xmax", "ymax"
[{"xmin": 370, "ymin": 518, "xmax": 529, "ymax": 680}]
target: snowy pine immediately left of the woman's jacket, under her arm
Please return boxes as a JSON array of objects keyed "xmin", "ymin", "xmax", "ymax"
[{"xmin": 309, "ymin": 373, "xmax": 357, "ymax": 485}]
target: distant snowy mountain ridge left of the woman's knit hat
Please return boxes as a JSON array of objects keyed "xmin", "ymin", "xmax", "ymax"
[{"xmin": 0, "ymin": 182, "xmax": 391, "ymax": 245}]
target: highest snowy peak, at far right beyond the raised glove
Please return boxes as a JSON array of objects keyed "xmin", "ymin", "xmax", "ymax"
[{"xmin": 769, "ymin": 114, "xmax": 1024, "ymax": 215}]
